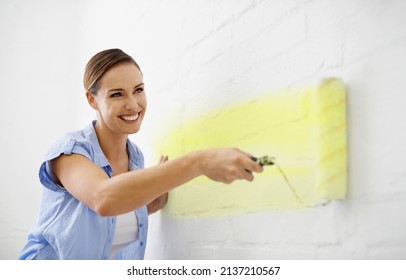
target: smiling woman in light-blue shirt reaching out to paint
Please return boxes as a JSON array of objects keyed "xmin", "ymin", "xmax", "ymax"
[{"xmin": 20, "ymin": 49, "xmax": 262, "ymax": 259}]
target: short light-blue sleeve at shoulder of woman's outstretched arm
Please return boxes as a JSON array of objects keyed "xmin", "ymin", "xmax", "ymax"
[{"xmin": 39, "ymin": 137, "xmax": 93, "ymax": 192}]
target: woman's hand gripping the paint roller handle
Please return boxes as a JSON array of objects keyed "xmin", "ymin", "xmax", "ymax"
[{"xmin": 202, "ymin": 149, "xmax": 263, "ymax": 184}]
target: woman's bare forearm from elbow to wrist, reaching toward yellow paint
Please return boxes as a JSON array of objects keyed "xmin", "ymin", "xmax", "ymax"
[{"xmin": 95, "ymin": 152, "xmax": 204, "ymax": 216}]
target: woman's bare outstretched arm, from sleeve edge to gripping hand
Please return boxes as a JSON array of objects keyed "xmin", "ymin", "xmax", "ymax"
[{"xmin": 51, "ymin": 149, "xmax": 262, "ymax": 216}]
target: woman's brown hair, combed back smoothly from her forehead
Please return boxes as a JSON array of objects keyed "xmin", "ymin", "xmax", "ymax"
[{"xmin": 83, "ymin": 49, "xmax": 141, "ymax": 95}]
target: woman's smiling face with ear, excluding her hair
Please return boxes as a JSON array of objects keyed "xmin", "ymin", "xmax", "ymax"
[{"xmin": 86, "ymin": 63, "xmax": 147, "ymax": 135}]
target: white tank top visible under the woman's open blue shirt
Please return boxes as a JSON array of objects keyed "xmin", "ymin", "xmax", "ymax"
[{"xmin": 110, "ymin": 211, "xmax": 138, "ymax": 259}]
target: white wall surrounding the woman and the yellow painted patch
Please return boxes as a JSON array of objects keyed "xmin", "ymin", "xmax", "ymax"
[{"xmin": 0, "ymin": 0, "xmax": 406, "ymax": 259}]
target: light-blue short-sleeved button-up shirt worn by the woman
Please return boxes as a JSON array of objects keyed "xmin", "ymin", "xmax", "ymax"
[{"xmin": 19, "ymin": 121, "xmax": 148, "ymax": 260}]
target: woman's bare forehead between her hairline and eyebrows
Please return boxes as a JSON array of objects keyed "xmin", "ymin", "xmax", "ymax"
[{"xmin": 100, "ymin": 62, "xmax": 143, "ymax": 88}]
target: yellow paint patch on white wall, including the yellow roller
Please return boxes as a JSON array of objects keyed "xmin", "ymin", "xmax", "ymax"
[{"xmin": 157, "ymin": 79, "xmax": 347, "ymax": 218}]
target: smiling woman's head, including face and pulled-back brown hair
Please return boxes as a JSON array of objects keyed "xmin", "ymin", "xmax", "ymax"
[{"xmin": 83, "ymin": 49, "xmax": 147, "ymax": 137}]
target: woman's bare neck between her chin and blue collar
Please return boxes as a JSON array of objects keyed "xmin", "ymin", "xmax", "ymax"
[{"xmin": 95, "ymin": 121, "xmax": 128, "ymax": 162}]
